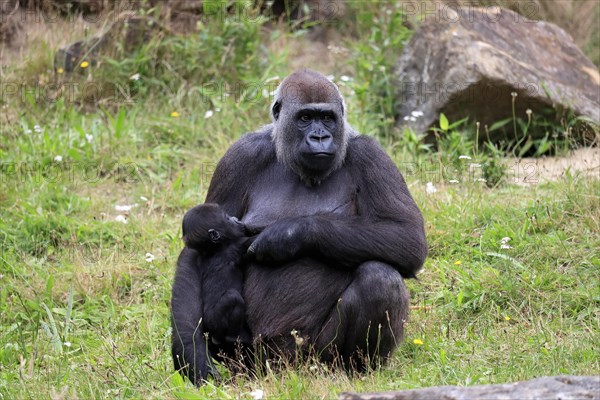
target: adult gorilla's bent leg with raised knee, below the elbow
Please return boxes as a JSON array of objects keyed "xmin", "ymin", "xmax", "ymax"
[{"xmin": 315, "ymin": 261, "xmax": 409, "ymax": 370}]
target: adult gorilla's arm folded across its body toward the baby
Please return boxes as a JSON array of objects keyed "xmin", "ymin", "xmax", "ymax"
[{"xmin": 251, "ymin": 136, "xmax": 427, "ymax": 278}]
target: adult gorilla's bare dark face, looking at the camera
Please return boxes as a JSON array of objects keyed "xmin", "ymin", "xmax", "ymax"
[{"xmin": 294, "ymin": 104, "xmax": 340, "ymax": 173}]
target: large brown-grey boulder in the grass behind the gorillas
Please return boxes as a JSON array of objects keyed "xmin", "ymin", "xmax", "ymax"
[{"xmin": 396, "ymin": 7, "xmax": 600, "ymax": 136}]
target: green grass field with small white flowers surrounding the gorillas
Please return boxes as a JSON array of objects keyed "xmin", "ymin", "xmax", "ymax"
[{"xmin": 0, "ymin": 1, "xmax": 600, "ymax": 399}]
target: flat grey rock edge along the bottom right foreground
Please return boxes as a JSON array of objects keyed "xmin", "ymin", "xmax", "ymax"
[{"xmin": 339, "ymin": 376, "xmax": 600, "ymax": 400}]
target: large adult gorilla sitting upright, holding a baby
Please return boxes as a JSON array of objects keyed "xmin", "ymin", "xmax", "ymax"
[{"xmin": 172, "ymin": 70, "xmax": 427, "ymax": 383}]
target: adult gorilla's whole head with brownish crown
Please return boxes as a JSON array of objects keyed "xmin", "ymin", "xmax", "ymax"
[{"xmin": 271, "ymin": 70, "xmax": 351, "ymax": 185}]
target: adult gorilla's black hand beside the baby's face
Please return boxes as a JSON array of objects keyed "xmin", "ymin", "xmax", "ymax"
[{"xmin": 248, "ymin": 217, "xmax": 312, "ymax": 265}]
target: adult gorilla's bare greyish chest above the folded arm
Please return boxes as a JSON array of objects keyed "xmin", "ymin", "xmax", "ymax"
[{"xmin": 242, "ymin": 168, "xmax": 357, "ymax": 226}]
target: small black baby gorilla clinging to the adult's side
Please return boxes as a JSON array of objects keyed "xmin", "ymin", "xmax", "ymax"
[{"xmin": 183, "ymin": 203, "xmax": 258, "ymax": 344}]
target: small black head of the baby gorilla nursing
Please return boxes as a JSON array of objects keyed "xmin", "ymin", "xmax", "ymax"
[{"xmin": 182, "ymin": 203, "xmax": 246, "ymax": 251}]
